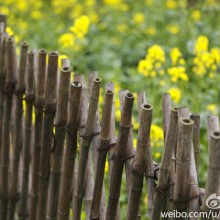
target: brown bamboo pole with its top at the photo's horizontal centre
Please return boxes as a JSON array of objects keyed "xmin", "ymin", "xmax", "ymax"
[{"xmin": 90, "ymin": 90, "xmax": 113, "ymax": 219}]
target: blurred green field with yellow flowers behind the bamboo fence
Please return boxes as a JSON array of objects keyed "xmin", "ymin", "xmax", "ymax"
[{"xmin": 0, "ymin": 0, "xmax": 220, "ymax": 218}]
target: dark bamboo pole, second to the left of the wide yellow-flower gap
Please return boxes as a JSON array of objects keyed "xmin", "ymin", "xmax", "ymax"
[{"xmin": 106, "ymin": 93, "xmax": 134, "ymax": 220}]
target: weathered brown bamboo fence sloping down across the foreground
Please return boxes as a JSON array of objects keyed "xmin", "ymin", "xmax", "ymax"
[{"xmin": 0, "ymin": 14, "xmax": 220, "ymax": 220}]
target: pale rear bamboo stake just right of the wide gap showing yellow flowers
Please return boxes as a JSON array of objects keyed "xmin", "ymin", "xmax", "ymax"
[{"xmin": 162, "ymin": 93, "xmax": 171, "ymax": 143}]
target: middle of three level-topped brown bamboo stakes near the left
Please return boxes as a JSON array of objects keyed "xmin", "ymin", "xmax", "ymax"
[{"xmin": 29, "ymin": 49, "xmax": 47, "ymax": 220}]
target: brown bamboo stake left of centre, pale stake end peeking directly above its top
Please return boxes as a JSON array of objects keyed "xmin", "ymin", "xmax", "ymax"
[{"xmin": 47, "ymin": 67, "xmax": 71, "ymax": 220}]
